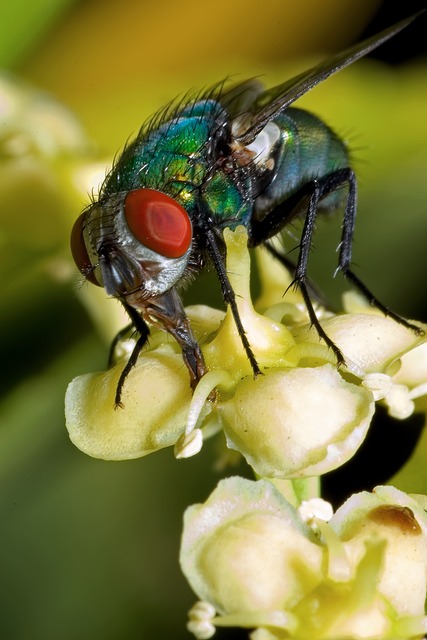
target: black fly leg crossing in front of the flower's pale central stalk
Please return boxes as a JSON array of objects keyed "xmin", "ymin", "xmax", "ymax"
[{"xmin": 205, "ymin": 228, "xmax": 261, "ymax": 376}]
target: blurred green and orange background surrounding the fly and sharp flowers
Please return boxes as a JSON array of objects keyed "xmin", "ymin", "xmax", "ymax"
[{"xmin": 0, "ymin": 0, "xmax": 427, "ymax": 640}]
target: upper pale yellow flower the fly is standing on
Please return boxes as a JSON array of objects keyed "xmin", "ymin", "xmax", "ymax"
[{"xmin": 66, "ymin": 222, "xmax": 423, "ymax": 478}]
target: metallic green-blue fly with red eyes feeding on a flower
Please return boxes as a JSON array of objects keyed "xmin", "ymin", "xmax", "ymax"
[{"xmin": 71, "ymin": 14, "xmax": 421, "ymax": 405}]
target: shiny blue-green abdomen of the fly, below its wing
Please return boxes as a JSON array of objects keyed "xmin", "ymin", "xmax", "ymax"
[{"xmin": 255, "ymin": 108, "xmax": 349, "ymax": 216}]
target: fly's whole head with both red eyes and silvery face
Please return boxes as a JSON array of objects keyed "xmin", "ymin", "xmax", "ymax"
[{"xmin": 71, "ymin": 189, "xmax": 192, "ymax": 304}]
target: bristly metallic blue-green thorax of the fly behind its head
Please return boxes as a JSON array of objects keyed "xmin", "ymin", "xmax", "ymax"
[{"xmin": 102, "ymin": 100, "xmax": 251, "ymax": 228}]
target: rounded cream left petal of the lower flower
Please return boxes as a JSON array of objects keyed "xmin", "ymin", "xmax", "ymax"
[{"xmin": 180, "ymin": 477, "xmax": 322, "ymax": 614}]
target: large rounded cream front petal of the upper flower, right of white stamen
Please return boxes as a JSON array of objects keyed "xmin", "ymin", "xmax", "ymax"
[{"xmin": 218, "ymin": 364, "xmax": 374, "ymax": 478}]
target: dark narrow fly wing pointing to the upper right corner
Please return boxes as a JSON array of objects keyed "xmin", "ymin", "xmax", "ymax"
[{"xmin": 234, "ymin": 11, "xmax": 424, "ymax": 146}]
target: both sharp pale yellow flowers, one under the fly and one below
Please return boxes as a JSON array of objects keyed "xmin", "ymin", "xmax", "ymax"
[{"xmin": 66, "ymin": 228, "xmax": 427, "ymax": 640}]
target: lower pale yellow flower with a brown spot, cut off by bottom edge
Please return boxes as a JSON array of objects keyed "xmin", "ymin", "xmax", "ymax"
[{"xmin": 180, "ymin": 478, "xmax": 427, "ymax": 640}]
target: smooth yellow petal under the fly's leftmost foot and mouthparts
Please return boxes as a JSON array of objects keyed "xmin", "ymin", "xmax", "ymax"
[{"xmin": 65, "ymin": 349, "xmax": 191, "ymax": 460}]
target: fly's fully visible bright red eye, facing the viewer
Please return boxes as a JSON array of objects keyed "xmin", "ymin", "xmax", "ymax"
[{"xmin": 124, "ymin": 189, "xmax": 192, "ymax": 258}]
